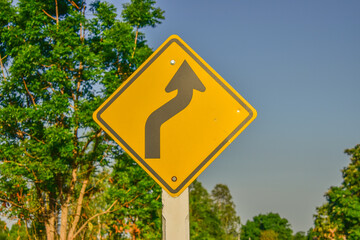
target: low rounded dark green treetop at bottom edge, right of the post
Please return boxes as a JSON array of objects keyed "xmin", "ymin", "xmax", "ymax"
[{"xmin": 240, "ymin": 213, "xmax": 292, "ymax": 240}]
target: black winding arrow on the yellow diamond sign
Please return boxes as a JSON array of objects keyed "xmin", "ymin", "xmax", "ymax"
[{"xmin": 145, "ymin": 60, "xmax": 206, "ymax": 158}]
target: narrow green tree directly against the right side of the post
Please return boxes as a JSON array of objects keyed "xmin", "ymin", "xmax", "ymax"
[{"xmin": 189, "ymin": 181, "xmax": 225, "ymax": 240}]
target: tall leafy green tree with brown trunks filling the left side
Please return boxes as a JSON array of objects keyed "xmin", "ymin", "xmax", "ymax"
[{"xmin": 0, "ymin": 0, "xmax": 163, "ymax": 240}]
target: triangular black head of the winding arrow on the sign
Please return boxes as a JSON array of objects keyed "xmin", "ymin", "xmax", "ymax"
[{"xmin": 165, "ymin": 60, "xmax": 206, "ymax": 92}]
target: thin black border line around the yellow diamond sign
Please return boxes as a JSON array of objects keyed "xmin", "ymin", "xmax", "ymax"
[{"xmin": 96, "ymin": 39, "xmax": 254, "ymax": 194}]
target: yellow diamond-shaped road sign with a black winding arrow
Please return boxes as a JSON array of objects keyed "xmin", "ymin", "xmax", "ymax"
[{"xmin": 93, "ymin": 35, "xmax": 256, "ymax": 197}]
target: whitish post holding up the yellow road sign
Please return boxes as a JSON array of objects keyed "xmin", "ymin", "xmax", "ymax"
[{"xmin": 162, "ymin": 188, "xmax": 190, "ymax": 240}]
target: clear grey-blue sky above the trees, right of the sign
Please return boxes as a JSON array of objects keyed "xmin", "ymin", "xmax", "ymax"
[{"xmin": 112, "ymin": 0, "xmax": 360, "ymax": 232}]
